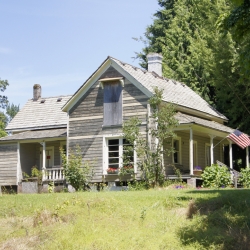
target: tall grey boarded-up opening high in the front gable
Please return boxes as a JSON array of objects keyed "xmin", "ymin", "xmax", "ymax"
[{"xmin": 103, "ymin": 81, "xmax": 122, "ymax": 126}]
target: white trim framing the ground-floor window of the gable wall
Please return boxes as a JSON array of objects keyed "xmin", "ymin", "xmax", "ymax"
[{"xmin": 102, "ymin": 134, "xmax": 137, "ymax": 175}]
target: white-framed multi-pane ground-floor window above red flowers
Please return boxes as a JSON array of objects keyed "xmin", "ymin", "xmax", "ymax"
[{"xmin": 104, "ymin": 138, "xmax": 134, "ymax": 171}]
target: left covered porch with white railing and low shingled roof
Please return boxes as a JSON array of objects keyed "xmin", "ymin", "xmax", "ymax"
[{"xmin": 1, "ymin": 128, "xmax": 67, "ymax": 183}]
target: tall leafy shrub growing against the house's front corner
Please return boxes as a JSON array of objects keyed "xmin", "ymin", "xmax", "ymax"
[{"xmin": 123, "ymin": 88, "xmax": 178, "ymax": 186}]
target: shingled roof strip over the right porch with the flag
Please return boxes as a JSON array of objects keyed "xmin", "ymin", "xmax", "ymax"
[{"xmin": 175, "ymin": 112, "xmax": 234, "ymax": 134}]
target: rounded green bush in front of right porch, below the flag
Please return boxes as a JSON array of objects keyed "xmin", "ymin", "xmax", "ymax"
[{"xmin": 201, "ymin": 164, "xmax": 232, "ymax": 188}]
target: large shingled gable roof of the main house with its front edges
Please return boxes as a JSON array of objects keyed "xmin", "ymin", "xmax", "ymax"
[{"xmin": 63, "ymin": 56, "xmax": 227, "ymax": 121}]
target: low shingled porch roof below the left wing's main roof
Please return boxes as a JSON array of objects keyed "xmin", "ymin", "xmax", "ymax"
[{"xmin": 0, "ymin": 128, "xmax": 67, "ymax": 142}]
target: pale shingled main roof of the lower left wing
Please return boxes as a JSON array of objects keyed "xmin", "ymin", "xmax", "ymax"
[{"xmin": 6, "ymin": 95, "xmax": 71, "ymax": 131}]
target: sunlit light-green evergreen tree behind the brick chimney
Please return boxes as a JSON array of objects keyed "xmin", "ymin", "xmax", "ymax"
[{"xmin": 137, "ymin": 0, "xmax": 238, "ymax": 105}]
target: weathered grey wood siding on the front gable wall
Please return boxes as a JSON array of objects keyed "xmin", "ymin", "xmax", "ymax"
[{"xmin": 69, "ymin": 67, "xmax": 148, "ymax": 181}]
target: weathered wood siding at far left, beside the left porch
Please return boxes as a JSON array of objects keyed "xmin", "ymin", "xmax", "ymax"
[{"xmin": 0, "ymin": 143, "xmax": 17, "ymax": 186}]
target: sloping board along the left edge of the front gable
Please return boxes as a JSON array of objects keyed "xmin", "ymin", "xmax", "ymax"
[{"xmin": 62, "ymin": 59, "xmax": 111, "ymax": 112}]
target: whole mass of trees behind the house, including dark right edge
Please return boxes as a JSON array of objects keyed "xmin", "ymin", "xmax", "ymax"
[{"xmin": 137, "ymin": 0, "xmax": 250, "ymax": 137}]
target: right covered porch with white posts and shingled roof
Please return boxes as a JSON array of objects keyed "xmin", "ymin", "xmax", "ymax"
[{"xmin": 164, "ymin": 112, "xmax": 249, "ymax": 179}]
